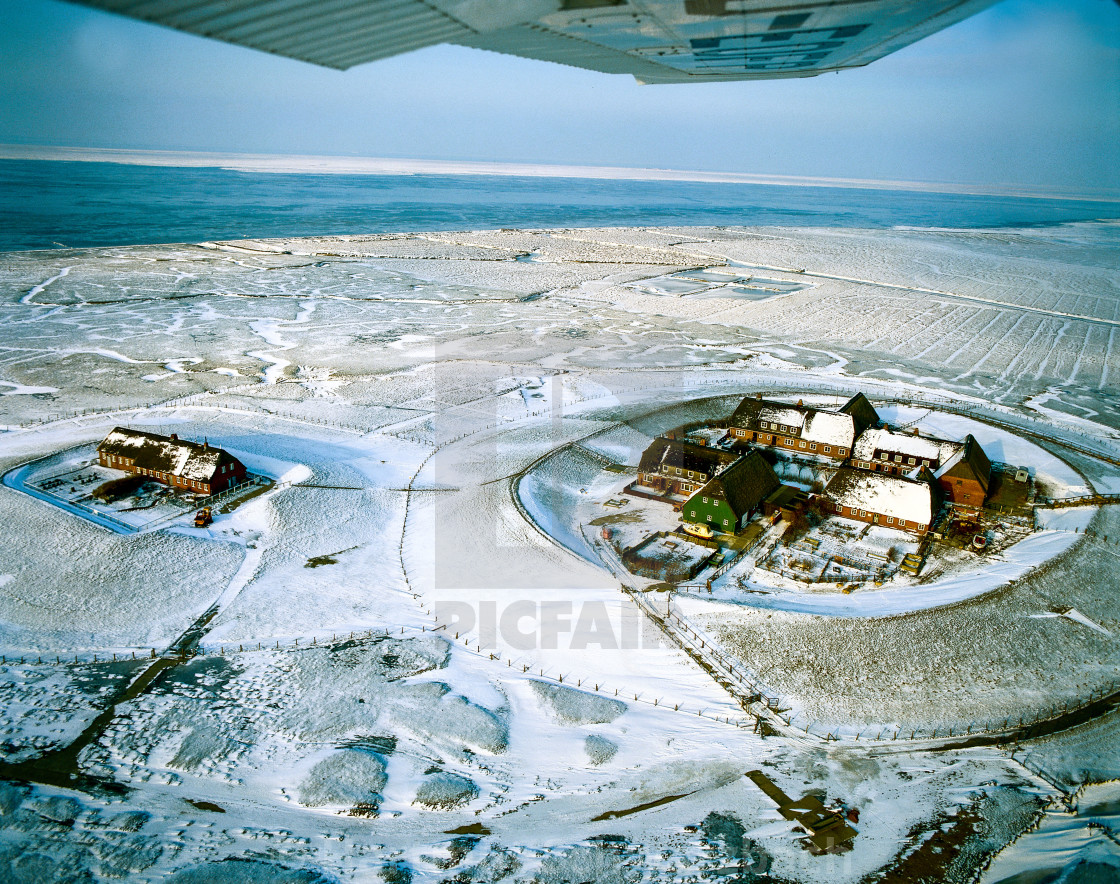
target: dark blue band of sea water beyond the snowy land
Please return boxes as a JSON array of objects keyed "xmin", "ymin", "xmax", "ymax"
[{"xmin": 0, "ymin": 160, "xmax": 1120, "ymax": 251}]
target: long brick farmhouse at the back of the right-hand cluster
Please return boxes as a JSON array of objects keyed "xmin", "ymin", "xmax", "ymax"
[{"xmin": 729, "ymin": 393, "xmax": 879, "ymax": 460}]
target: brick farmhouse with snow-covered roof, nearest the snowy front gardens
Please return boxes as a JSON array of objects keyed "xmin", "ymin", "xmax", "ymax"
[{"xmin": 824, "ymin": 466, "xmax": 937, "ymax": 534}]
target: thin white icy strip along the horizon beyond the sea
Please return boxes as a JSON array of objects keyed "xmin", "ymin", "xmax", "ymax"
[{"xmin": 0, "ymin": 145, "xmax": 1120, "ymax": 203}]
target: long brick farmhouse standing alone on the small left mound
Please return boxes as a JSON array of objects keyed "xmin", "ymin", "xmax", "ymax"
[{"xmin": 97, "ymin": 427, "xmax": 246, "ymax": 494}]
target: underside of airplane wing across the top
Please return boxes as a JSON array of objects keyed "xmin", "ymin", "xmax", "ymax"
[{"xmin": 67, "ymin": 0, "xmax": 996, "ymax": 83}]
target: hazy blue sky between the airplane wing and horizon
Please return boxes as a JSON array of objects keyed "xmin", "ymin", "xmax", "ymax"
[{"xmin": 0, "ymin": 0, "xmax": 1120, "ymax": 192}]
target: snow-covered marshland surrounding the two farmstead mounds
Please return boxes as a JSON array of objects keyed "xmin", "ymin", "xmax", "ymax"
[{"xmin": 0, "ymin": 223, "xmax": 1120, "ymax": 884}]
